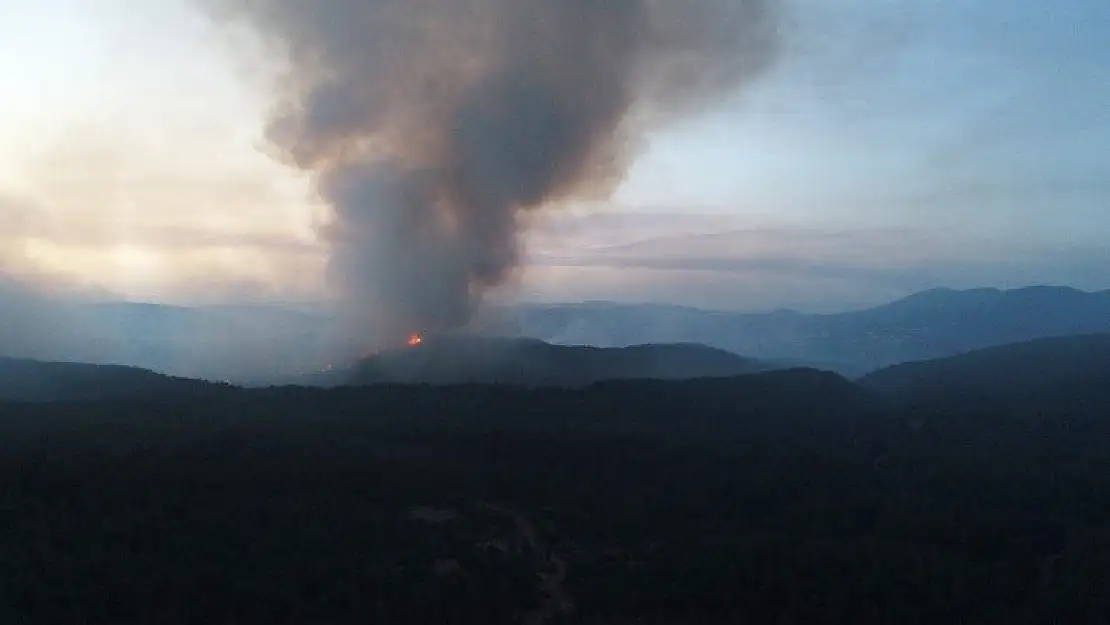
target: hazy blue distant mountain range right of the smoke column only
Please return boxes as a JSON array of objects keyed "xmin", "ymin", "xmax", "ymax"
[{"xmin": 516, "ymin": 286, "xmax": 1110, "ymax": 376}]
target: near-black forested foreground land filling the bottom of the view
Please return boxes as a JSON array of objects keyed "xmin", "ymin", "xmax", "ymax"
[{"xmin": 0, "ymin": 340, "xmax": 1110, "ymax": 625}]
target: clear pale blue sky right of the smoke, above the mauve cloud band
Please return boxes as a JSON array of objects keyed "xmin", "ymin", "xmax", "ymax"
[{"xmin": 625, "ymin": 0, "xmax": 1110, "ymax": 232}]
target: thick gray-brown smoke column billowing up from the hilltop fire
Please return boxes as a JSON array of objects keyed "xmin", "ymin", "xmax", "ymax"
[{"xmin": 202, "ymin": 0, "xmax": 775, "ymax": 353}]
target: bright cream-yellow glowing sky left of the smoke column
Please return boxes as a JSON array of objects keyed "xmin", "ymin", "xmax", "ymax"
[{"xmin": 0, "ymin": 0, "xmax": 320, "ymax": 299}]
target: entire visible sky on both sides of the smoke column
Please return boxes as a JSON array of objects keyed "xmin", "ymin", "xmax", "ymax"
[{"xmin": 0, "ymin": 0, "xmax": 1110, "ymax": 311}]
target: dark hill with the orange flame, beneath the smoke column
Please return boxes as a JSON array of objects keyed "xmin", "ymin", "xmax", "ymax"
[{"xmin": 345, "ymin": 336, "xmax": 771, "ymax": 386}]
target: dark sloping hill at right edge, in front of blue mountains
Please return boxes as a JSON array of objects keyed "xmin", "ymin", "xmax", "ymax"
[{"xmin": 859, "ymin": 334, "xmax": 1110, "ymax": 401}]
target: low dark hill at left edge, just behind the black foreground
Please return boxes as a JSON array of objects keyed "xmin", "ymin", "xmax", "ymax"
[{"xmin": 0, "ymin": 357, "xmax": 219, "ymax": 402}]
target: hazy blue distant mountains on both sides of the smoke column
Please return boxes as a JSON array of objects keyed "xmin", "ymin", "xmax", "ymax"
[{"xmin": 0, "ymin": 286, "xmax": 1110, "ymax": 384}]
